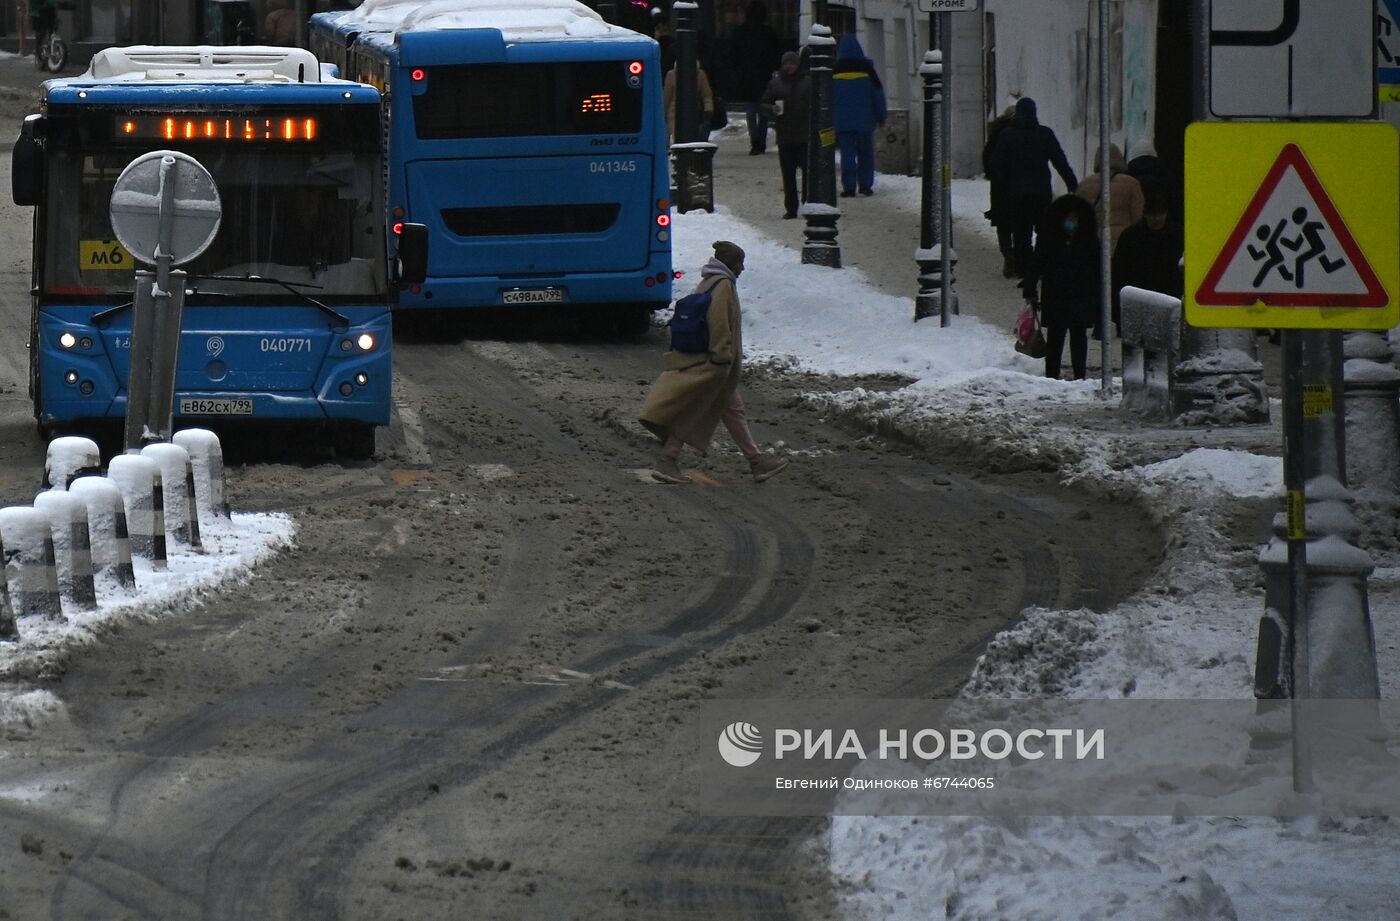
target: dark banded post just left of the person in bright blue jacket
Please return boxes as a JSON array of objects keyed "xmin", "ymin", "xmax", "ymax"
[{"xmin": 801, "ymin": 24, "xmax": 841, "ymax": 269}]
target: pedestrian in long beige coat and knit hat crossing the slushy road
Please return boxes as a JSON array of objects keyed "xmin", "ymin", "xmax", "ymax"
[{"xmin": 640, "ymin": 241, "xmax": 788, "ymax": 483}]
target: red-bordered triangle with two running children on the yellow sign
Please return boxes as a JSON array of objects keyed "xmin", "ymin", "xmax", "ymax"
[{"xmin": 1196, "ymin": 144, "xmax": 1390, "ymax": 308}]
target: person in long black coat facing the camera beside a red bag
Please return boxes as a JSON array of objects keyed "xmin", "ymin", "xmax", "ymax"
[{"xmin": 1021, "ymin": 195, "xmax": 1103, "ymax": 381}]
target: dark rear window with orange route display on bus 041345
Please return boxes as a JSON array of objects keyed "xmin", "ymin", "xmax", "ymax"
[{"xmin": 413, "ymin": 60, "xmax": 643, "ymax": 140}]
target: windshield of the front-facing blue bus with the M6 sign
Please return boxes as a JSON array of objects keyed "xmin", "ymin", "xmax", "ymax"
[{"xmin": 42, "ymin": 146, "xmax": 386, "ymax": 304}]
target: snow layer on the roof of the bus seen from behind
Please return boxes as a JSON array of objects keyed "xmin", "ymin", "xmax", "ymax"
[{"xmin": 336, "ymin": 0, "xmax": 633, "ymax": 41}]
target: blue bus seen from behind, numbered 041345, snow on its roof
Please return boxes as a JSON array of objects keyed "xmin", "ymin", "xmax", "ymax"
[{"xmin": 311, "ymin": 0, "xmax": 672, "ymax": 332}]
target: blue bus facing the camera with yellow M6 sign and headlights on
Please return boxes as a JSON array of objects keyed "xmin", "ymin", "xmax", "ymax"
[{"xmin": 11, "ymin": 46, "xmax": 420, "ymax": 458}]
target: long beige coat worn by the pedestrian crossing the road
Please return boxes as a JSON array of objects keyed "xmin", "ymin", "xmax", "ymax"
[{"xmin": 640, "ymin": 268, "xmax": 743, "ymax": 454}]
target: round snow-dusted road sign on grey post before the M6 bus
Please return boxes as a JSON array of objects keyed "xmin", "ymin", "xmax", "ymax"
[{"xmin": 111, "ymin": 150, "xmax": 223, "ymax": 451}]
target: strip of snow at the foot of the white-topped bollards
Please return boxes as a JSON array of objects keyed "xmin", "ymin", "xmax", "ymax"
[{"xmin": 0, "ymin": 514, "xmax": 295, "ymax": 680}]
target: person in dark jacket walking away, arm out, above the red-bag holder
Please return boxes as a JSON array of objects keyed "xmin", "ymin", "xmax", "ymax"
[{"xmin": 991, "ymin": 97, "xmax": 1079, "ymax": 279}]
